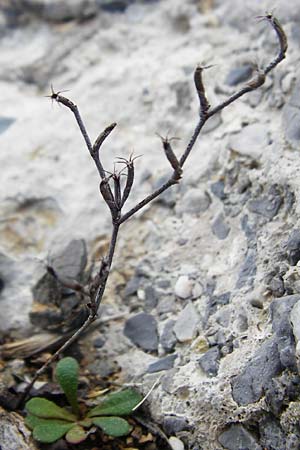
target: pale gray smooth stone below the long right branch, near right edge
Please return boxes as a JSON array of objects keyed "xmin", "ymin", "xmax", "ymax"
[{"xmin": 228, "ymin": 123, "xmax": 269, "ymax": 159}]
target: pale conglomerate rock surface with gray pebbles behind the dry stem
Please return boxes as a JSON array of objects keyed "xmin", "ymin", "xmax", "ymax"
[{"xmin": 0, "ymin": 0, "xmax": 300, "ymax": 450}]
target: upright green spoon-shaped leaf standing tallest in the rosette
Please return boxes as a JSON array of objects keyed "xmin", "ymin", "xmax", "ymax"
[{"xmin": 55, "ymin": 356, "xmax": 79, "ymax": 414}]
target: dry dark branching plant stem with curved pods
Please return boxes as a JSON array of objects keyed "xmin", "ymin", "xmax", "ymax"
[{"xmin": 21, "ymin": 14, "xmax": 287, "ymax": 402}]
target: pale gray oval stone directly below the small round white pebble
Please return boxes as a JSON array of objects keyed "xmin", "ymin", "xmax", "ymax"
[{"xmin": 174, "ymin": 303, "xmax": 200, "ymax": 342}]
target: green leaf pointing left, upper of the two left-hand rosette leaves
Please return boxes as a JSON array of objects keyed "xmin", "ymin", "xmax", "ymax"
[{"xmin": 25, "ymin": 397, "xmax": 76, "ymax": 422}]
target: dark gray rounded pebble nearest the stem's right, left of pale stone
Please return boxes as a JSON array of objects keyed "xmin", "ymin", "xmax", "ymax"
[{"xmin": 124, "ymin": 313, "xmax": 158, "ymax": 351}]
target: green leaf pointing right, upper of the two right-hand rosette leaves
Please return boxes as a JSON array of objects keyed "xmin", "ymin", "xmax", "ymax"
[{"xmin": 88, "ymin": 389, "xmax": 143, "ymax": 417}]
